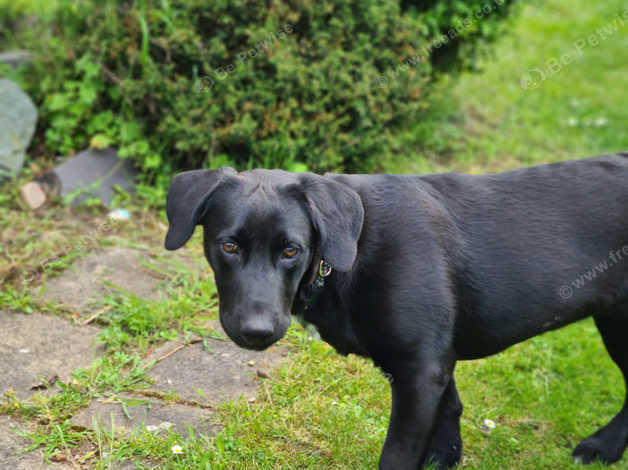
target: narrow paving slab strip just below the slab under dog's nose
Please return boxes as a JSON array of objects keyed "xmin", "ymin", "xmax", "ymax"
[{"xmin": 72, "ymin": 395, "xmax": 220, "ymax": 436}]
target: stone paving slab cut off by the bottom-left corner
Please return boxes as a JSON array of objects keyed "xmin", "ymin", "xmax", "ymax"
[{"xmin": 0, "ymin": 416, "xmax": 72, "ymax": 470}]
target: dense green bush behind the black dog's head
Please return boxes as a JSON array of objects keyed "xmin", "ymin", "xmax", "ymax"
[{"xmin": 0, "ymin": 0, "xmax": 517, "ymax": 182}]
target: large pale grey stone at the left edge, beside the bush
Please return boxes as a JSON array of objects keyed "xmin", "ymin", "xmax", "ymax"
[{"xmin": 0, "ymin": 79, "xmax": 37, "ymax": 181}]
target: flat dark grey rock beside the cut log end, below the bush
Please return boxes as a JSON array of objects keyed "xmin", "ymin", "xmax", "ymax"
[{"xmin": 40, "ymin": 148, "xmax": 137, "ymax": 206}]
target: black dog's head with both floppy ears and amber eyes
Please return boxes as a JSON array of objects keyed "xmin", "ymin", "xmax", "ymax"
[{"xmin": 166, "ymin": 168, "xmax": 364, "ymax": 350}]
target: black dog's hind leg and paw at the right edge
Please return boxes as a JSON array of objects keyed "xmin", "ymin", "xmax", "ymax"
[{"xmin": 573, "ymin": 304, "xmax": 628, "ymax": 464}]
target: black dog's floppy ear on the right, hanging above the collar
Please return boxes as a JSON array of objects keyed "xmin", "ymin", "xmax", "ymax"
[{"xmin": 300, "ymin": 174, "xmax": 364, "ymax": 271}]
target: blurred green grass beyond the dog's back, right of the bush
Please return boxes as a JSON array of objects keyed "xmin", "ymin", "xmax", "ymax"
[{"xmin": 387, "ymin": 0, "xmax": 628, "ymax": 173}]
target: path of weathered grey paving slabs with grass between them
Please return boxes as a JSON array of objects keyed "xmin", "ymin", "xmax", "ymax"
[{"xmin": 0, "ymin": 247, "xmax": 287, "ymax": 470}]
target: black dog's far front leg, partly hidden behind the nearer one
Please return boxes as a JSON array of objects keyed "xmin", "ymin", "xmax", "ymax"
[{"xmin": 426, "ymin": 376, "xmax": 462, "ymax": 469}]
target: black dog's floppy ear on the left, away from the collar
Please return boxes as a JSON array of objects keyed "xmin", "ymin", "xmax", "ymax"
[{"xmin": 166, "ymin": 167, "xmax": 236, "ymax": 250}]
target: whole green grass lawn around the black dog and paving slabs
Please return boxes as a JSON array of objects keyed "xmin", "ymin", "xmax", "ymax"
[{"xmin": 0, "ymin": 0, "xmax": 628, "ymax": 470}]
